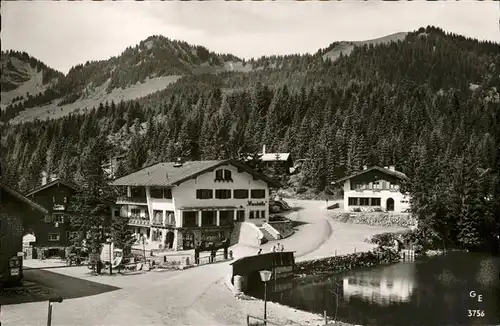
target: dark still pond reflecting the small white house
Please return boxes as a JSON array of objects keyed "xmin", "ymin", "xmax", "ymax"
[{"xmin": 251, "ymin": 252, "xmax": 500, "ymax": 326}]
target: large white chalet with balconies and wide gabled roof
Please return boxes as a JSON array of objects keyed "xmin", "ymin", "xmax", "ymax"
[{"xmin": 111, "ymin": 160, "xmax": 280, "ymax": 250}]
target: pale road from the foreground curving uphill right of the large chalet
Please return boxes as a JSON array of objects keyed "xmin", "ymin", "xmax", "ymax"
[{"xmin": 2, "ymin": 201, "xmax": 390, "ymax": 326}]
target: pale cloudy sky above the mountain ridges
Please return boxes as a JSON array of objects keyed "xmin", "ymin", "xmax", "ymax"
[{"xmin": 0, "ymin": 0, "xmax": 500, "ymax": 73}]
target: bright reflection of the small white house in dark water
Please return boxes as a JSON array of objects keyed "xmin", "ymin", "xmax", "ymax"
[{"xmin": 343, "ymin": 263, "xmax": 416, "ymax": 306}]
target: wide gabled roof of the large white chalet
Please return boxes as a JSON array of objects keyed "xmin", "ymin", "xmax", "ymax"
[{"xmin": 110, "ymin": 159, "xmax": 281, "ymax": 188}]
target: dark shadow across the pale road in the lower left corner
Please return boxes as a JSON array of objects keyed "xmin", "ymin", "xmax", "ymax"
[{"xmin": 0, "ymin": 270, "xmax": 120, "ymax": 305}]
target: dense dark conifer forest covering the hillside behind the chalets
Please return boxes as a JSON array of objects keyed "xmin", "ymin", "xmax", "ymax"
[{"xmin": 1, "ymin": 27, "xmax": 500, "ymax": 249}]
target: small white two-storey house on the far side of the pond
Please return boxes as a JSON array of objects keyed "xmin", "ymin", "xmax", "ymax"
[{"xmin": 332, "ymin": 165, "xmax": 410, "ymax": 212}]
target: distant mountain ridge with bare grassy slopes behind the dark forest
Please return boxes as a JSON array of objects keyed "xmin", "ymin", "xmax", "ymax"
[{"xmin": 2, "ymin": 33, "xmax": 405, "ymax": 122}]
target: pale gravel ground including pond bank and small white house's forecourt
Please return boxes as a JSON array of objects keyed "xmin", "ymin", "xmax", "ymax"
[{"xmin": 2, "ymin": 200, "xmax": 394, "ymax": 326}]
